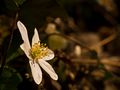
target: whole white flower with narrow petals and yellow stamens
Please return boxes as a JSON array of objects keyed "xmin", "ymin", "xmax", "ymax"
[{"xmin": 17, "ymin": 21, "xmax": 58, "ymax": 84}]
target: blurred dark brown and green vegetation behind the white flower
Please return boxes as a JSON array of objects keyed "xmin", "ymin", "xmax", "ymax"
[{"xmin": 0, "ymin": 0, "xmax": 120, "ymax": 90}]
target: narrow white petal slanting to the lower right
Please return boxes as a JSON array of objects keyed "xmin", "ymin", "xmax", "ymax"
[{"xmin": 38, "ymin": 60, "xmax": 58, "ymax": 80}]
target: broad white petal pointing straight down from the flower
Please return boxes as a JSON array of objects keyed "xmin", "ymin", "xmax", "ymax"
[{"xmin": 29, "ymin": 61, "xmax": 42, "ymax": 84}]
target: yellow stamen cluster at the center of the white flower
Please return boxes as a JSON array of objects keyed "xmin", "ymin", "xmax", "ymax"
[{"xmin": 30, "ymin": 43, "xmax": 48, "ymax": 60}]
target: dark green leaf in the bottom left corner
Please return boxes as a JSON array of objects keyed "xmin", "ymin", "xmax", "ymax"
[{"xmin": 0, "ymin": 66, "xmax": 22, "ymax": 90}]
